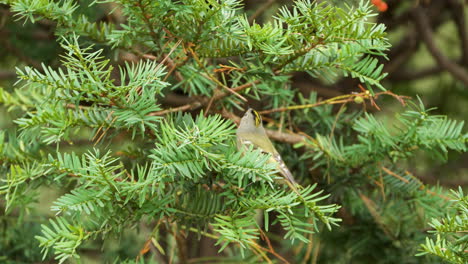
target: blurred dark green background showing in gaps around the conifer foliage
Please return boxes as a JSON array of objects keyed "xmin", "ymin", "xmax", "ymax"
[{"xmin": 0, "ymin": 0, "xmax": 468, "ymax": 263}]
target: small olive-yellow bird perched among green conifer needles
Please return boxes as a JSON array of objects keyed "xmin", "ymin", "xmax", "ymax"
[{"xmin": 236, "ymin": 108, "xmax": 297, "ymax": 190}]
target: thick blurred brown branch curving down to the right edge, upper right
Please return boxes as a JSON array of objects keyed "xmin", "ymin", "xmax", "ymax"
[{"xmin": 413, "ymin": 7, "xmax": 468, "ymax": 86}]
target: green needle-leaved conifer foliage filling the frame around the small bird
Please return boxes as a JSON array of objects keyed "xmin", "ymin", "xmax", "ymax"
[{"xmin": 0, "ymin": 0, "xmax": 468, "ymax": 263}]
